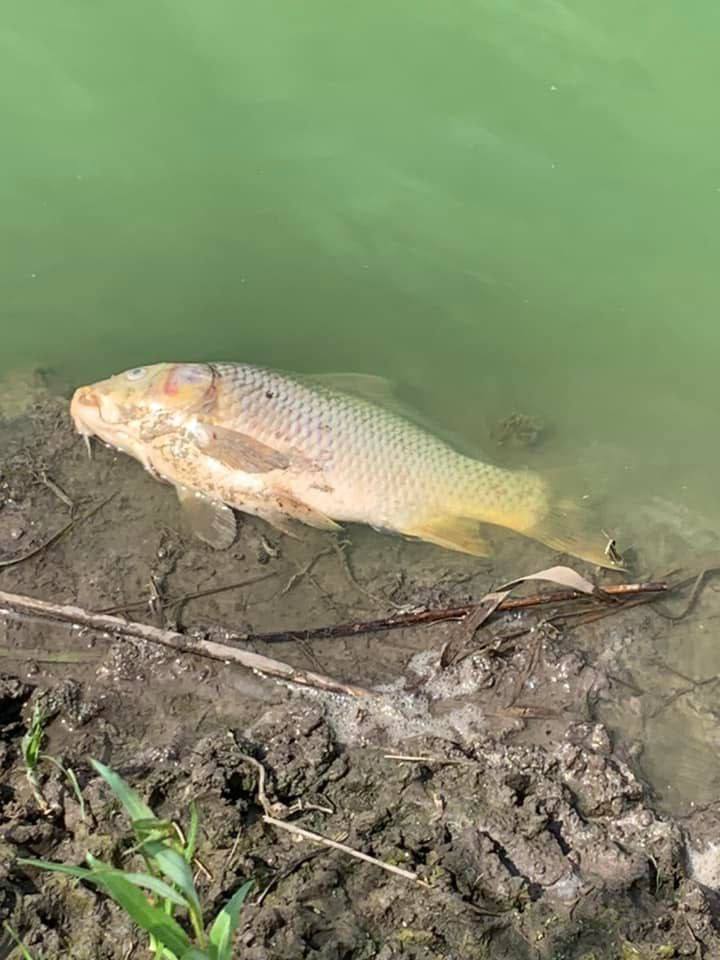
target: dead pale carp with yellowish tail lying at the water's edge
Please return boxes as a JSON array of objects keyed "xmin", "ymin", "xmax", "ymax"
[{"xmin": 71, "ymin": 363, "xmax": 616, "ymax": 567}]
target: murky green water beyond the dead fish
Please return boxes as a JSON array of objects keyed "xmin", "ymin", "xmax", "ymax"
[{"xmin": 0, "ymin": 0, "xmax": 720, "ymax": 808}]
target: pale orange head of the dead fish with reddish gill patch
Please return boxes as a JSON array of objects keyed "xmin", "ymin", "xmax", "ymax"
[{"xmin": 70, "ymin": 363, "xmax": 216, "ymax": 462}]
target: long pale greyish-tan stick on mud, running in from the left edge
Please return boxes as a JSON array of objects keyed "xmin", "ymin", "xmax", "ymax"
[{"xmin": 0, "ymin": 590, "xmax": 371, "ymax": 697}]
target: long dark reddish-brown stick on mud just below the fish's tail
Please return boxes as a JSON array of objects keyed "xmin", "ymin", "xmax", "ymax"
[{"xmin": 228, "ymin": 581, "xmax": 670, "ymax": 643}]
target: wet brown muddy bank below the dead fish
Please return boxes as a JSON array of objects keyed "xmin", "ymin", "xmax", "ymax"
[{"xmin": 0, "ymin": 386, "xmax": 720, "ymax": 960}]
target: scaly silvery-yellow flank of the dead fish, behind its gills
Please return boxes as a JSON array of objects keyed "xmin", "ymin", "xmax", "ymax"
[{"xmin": 212, "ymin": 363, "xmax": 532, "ymax": 515}]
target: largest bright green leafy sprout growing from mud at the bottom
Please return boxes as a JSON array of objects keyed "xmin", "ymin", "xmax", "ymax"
[{"xmin": 18, "ymin": 760, "xmax": 253, "ymax": 960}]
